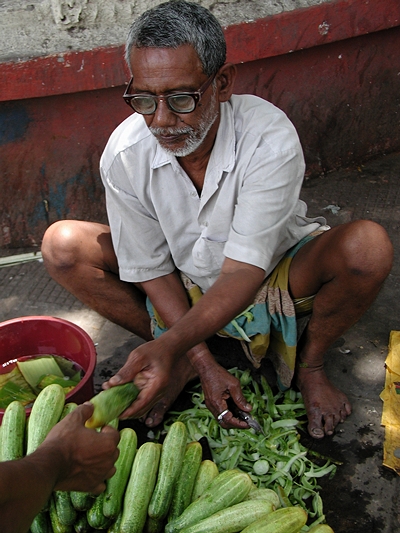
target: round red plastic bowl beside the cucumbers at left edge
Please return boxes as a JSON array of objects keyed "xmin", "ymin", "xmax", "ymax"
[{"xmin": 0, "ymin": 316, "xmax": 96, "ymax": 422}]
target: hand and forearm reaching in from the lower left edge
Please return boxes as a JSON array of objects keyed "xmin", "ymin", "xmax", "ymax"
[{"xmin": 0, "ymin": 402, "xmax": 119, "ymax": 533}]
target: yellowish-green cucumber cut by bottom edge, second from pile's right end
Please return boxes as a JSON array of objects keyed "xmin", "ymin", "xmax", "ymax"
[{"xmin": 242, "ymin": 506, "xmax": 307, "ymax": 533}]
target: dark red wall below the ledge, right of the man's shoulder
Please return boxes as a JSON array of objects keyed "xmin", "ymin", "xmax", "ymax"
[{"xmin": 237, "ymin": 27, "xmax": 400, "ymax": 175}]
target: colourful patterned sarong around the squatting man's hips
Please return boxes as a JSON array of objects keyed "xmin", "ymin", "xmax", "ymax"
[{"xmin": 147, "ymin": 226, "xmax": 329, "ymax": 389}]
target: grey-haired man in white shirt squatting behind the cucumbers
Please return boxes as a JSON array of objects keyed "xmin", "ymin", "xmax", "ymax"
[{"xmin": 42, "ymin": 0, "xmax": 392, "ymax": 438}]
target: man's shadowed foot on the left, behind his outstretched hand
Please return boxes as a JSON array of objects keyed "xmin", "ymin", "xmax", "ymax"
[{"xmin": 143, "ymin": 357, "xmax": 198, "ymax": 428}]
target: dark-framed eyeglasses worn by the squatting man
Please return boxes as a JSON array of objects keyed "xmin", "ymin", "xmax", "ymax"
[{"xmin": 123, "ymin": 74, "xmax": 215, "ymax": 115}]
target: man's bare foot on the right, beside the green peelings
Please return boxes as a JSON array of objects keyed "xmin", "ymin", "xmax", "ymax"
[{"xmin": 296, "ymin": 367, "xmax": 351, "ymax": 439}]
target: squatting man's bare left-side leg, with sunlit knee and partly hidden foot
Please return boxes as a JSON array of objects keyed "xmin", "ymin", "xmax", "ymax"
[{"xmin": 42, "ymin": 220, "xmax": 196, "ymax": 427}]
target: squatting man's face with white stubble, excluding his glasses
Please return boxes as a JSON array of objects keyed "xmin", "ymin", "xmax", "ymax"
[{"xmin": 130, "ymin": 45, "xmax": 219, "ymax": 157}]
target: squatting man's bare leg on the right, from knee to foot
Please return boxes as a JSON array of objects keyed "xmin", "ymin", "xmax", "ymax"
[{"xmin": 289, "ymin": 220, "xmax": 393, "ymax": 438}]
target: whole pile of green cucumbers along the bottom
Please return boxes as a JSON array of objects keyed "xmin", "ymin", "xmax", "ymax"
[{"xmin": 0, "ymin": 385, "xmax": 333, "ymax": 533}]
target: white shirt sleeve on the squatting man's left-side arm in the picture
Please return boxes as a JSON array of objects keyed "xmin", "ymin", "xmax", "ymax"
[{"xmin": 101, "ymin": 157, "xmax": 175, "ymax": 282}]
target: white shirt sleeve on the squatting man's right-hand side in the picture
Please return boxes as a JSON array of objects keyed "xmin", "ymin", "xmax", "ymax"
[{"xmin": 224, "ymin": 128, "xmax": 310, "ymax": 274}]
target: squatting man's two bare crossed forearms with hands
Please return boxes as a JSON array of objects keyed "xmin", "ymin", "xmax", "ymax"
[{"xmin": 105, "ymin": 259, "xmax": 264, "ymax": 427}]
